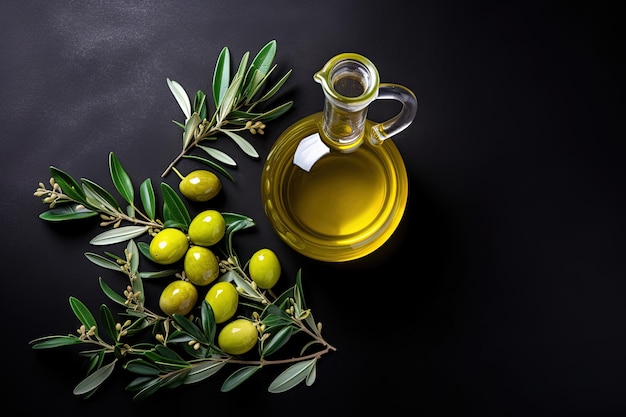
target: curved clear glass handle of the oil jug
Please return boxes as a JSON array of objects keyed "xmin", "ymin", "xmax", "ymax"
[{"xmin": 370, "ymin": 83, "xmax": 417, "ymax": 145}]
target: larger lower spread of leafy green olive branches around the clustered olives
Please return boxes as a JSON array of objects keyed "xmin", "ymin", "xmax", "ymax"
[{"xmin": 30, "ymin": 149, "xmax": 335, "ymax": 399}]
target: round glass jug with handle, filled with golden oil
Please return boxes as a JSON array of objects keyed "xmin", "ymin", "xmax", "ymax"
[{"xmin": 261, "ymin": 53, "xmax": 417, "ymax": 262}]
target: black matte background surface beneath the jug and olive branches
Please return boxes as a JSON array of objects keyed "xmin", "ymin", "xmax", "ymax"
[{"xmin": 0, "ymin": 0, "xmax": 626, "ymax": 416}]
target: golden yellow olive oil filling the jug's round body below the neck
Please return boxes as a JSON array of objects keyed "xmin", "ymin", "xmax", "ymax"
[{"xmin": 261, "ymin": 112, "xmax": 408, "ymax": 262}]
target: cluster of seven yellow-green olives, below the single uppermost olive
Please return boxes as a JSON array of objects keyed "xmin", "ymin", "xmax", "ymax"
[{"xmin": 149, "ymin": 209, "xmax": 281, "ymax": 355}]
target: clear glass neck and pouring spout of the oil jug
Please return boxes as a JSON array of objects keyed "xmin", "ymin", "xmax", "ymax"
[{"xmin": 313, "ymin": 53, "xmax": 380, "ymax": 152}]
